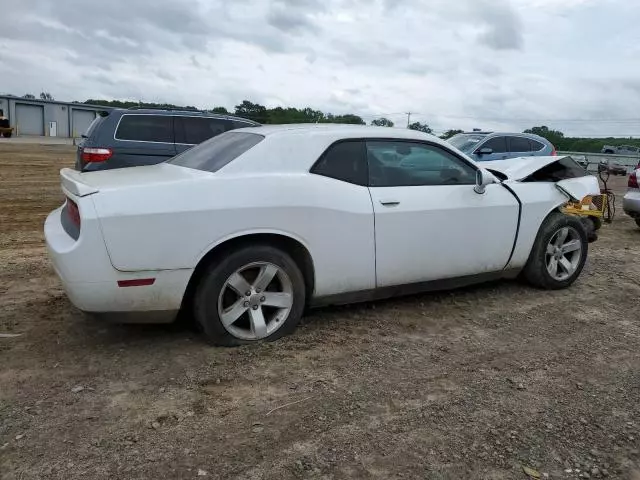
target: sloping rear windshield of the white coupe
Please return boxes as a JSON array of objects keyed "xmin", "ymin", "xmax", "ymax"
[{"xmin": 168, "ymin": 132, "xmax": 264, "ymax": 172}]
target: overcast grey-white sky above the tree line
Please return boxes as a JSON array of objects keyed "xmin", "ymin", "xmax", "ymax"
[{"xmin": 0, "ymin": 0, "xmax": 640, "ymax": 136}]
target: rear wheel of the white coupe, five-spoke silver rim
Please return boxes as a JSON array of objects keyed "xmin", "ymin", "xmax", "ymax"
[{"xmin": 193, "ymin": 245, "xmax": 305, "ymax": 347}]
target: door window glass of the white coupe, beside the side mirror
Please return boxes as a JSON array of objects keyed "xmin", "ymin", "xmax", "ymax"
[{"xmin": 367, "ymin": 140, "xmax": 476, "ymax": 187}]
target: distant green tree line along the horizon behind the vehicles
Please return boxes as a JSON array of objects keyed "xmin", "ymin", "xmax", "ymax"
[{"xmin": 13, "ymin": 92, "xmax": 640, "ymax": 152}]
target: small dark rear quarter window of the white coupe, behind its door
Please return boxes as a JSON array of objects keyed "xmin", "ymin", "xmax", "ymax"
[{"xmin": 311, "ymin": 140, "xmax": 368, "ymax": 185}]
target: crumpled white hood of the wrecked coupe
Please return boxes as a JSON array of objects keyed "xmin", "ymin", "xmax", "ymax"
[{"xmin": 481, "ymin": 156, "xmax": 600, "ymax": 202}]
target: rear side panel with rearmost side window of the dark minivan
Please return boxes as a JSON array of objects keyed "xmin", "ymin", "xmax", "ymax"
[{"xmin": 109, "ymin": 113, "xmax": 176, "ymax": 167}]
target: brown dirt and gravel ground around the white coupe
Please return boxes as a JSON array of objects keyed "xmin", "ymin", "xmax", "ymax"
[{"xmin": 0, "ymin": 142, "xmax": 640, "ymax": 480}]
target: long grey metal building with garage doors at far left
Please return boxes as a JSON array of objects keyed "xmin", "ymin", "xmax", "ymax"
[{"xmin": 0, "ymin": 95, "xmax": 111, "ymax": 138}]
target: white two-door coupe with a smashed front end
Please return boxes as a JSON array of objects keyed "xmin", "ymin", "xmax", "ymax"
[{"xmin": 44, "ymin": 125, "xmax": 599, "ymax": 345}]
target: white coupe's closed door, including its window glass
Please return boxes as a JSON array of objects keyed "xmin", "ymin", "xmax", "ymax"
[{"xmin": 366, "ymin": 140, "xmax": 519, "ymax": 287}]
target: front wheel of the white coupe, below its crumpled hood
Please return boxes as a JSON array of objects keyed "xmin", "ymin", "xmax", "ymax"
[{"xmin": 523, "ymin": 212, "xmax": 588, "ymax": 290}]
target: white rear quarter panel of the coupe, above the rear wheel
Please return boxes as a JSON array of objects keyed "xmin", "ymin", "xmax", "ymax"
[{"xmin": 92, "ymin": 173, "xmax": 375, "ymax": 295}]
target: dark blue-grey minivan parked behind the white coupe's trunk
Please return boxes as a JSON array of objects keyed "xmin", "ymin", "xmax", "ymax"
[{"xmin": 76, "ymin": 109, "xmax": 260, "ymax": 172}]
